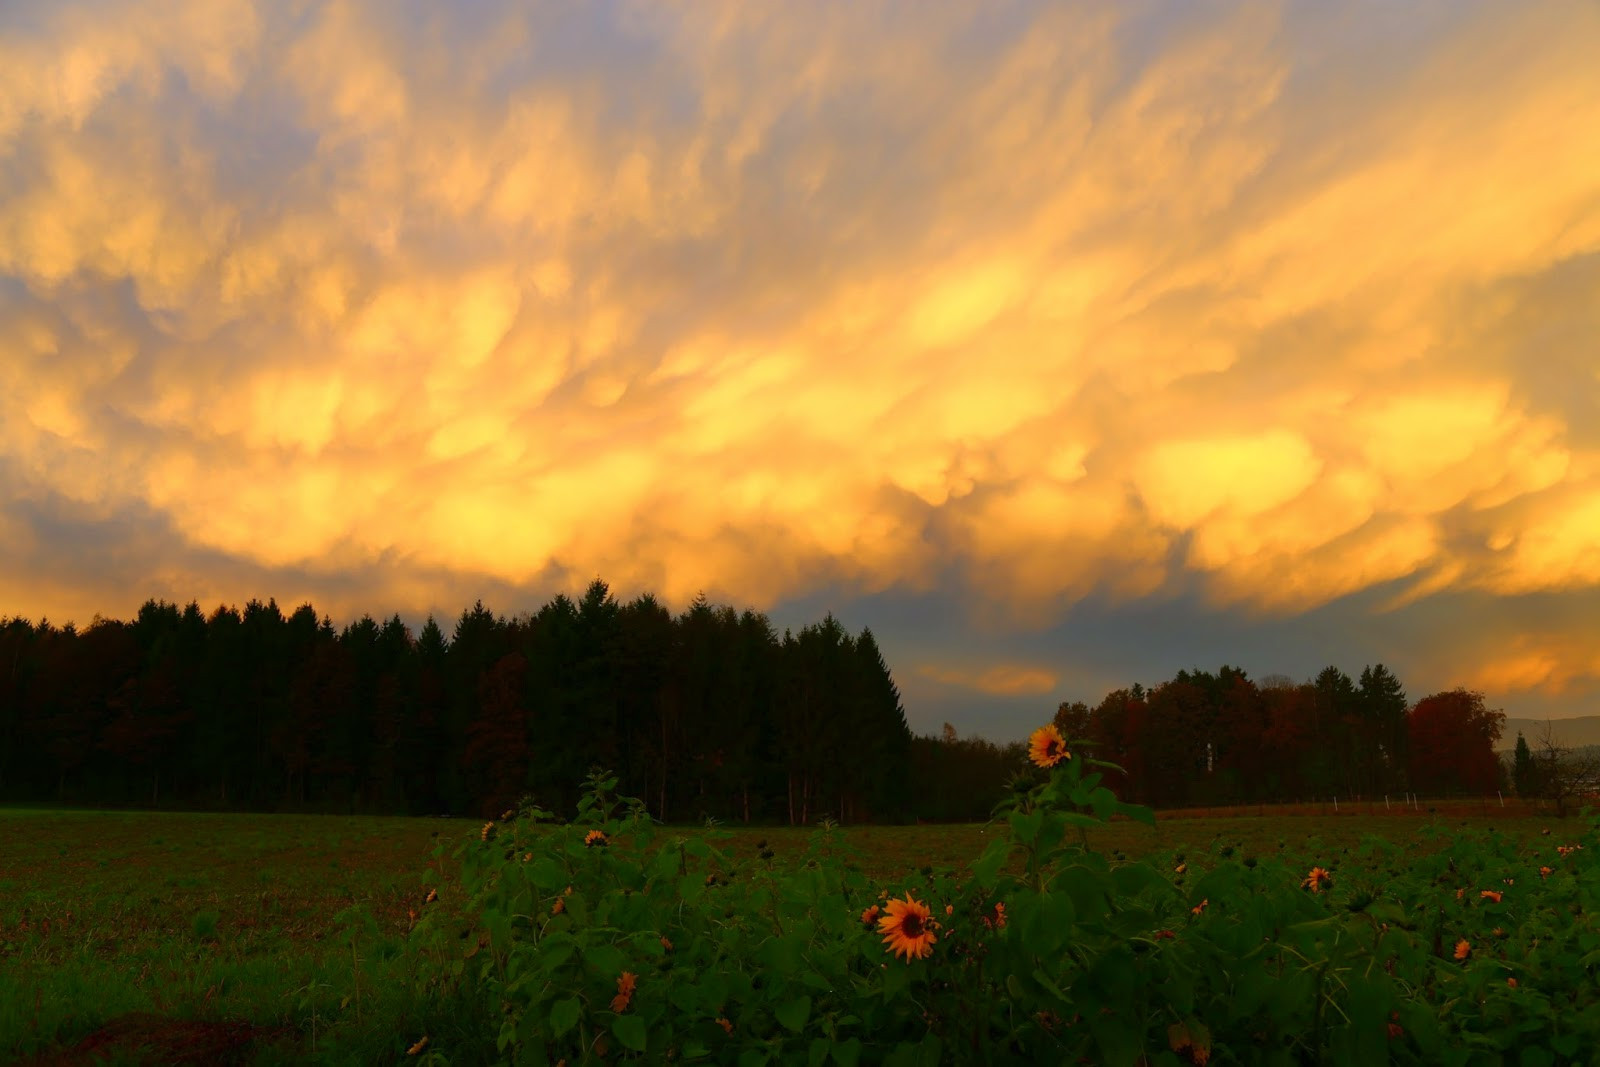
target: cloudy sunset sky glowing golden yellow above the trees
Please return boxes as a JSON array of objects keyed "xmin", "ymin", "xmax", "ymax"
[{"xmin": 0, "ymin": 0, "xmax": 1600, "ymax": 739}]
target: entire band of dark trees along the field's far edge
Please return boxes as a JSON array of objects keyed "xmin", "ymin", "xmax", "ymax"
[{"xmin": 0, "ymin": 579, "xmax": 1504, "ymax": 824}]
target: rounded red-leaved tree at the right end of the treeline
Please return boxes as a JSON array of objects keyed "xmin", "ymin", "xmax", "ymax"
[{"xmin": 1406, "ymin": 689, "xmax": 1506, "ymax": 793}]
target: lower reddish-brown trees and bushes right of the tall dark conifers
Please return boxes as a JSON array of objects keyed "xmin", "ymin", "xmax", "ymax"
[{"xmin": 912, "ymin": 664, "xmax": 1507, "ymax": 819}]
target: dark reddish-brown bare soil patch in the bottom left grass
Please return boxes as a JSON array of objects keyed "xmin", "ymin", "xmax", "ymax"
[{"xmin": 26, "ymin": 1013, "xmax": 294, "ymax": 1067}]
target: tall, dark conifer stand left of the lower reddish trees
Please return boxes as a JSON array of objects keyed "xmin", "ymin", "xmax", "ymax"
[{"xmin": 0, "ymin": 581, "xmax": 914, "ymax": 822}]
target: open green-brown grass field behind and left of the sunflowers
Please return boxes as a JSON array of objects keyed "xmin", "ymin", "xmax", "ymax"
[{"xmin": 0, "ymin": 801, "xmax": 1555, "ymax": 1064}]
